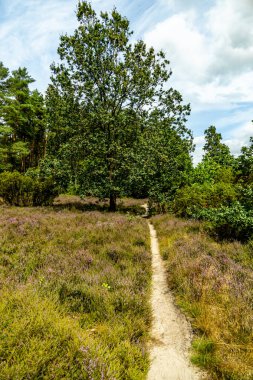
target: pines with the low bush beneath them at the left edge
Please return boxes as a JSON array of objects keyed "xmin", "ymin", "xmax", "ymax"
[{"xmin": 0, "ymin": 62, "xmax": 58, "ymax": 206}]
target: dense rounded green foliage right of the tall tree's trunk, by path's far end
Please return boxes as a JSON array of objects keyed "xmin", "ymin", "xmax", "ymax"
[{"xmin": 128, "ymin": 107, "xmax": 192, "ymax": 209}]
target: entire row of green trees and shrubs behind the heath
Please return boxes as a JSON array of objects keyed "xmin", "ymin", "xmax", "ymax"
[{"xmin": 0, "ymin": 1, "xmax": 253, "ymax": 239}]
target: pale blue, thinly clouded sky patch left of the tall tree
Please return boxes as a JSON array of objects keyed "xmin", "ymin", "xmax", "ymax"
[{"xmin": 0, "ymin": 0, "xmax": 76, "ymax": 90}]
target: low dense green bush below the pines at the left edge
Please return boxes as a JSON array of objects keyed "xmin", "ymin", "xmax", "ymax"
[{"xmin": 0, "ymin": 172, "xmax": 58, "ymax": 206}]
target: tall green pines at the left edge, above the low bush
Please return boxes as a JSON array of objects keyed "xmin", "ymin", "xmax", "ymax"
[{"xmin": 0, "ymin": 63, "xmax": 45, "ymax": 172}]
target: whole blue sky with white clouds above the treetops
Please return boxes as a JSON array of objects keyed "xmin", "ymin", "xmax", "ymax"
[{"xmin": 0, "ymin": 0, "xmax": 253, "ymax": 163}]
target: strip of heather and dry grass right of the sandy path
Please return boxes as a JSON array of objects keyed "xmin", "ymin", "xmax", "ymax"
[{"xmin": 152, "ymin": 215, "xmax": 253, "ymax": 380}]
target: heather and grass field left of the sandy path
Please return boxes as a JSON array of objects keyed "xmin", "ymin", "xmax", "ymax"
[{"xmin": 0, "ymin": 197, "xmax": 151, "ymax": 380}]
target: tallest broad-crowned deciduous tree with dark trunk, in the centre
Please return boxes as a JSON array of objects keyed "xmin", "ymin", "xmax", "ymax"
[{"xmin": 47, "ymin": 1, "xmax": 192, "ymax": 210}]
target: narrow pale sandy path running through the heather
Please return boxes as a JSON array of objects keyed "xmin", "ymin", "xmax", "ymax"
[{"xmin": 148, "ymin": 223, "xmax": 202, "ymax": 380}]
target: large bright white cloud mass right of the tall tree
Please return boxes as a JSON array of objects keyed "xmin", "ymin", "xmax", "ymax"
[{"xmin": 144, "ymin": 0, "xmax": 253, "ymax": 163}]
